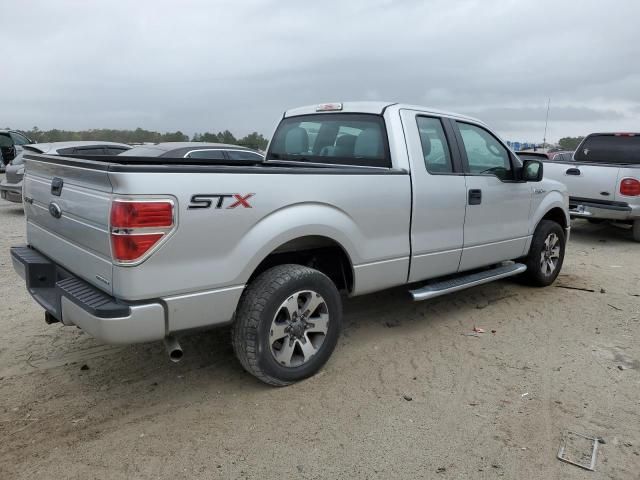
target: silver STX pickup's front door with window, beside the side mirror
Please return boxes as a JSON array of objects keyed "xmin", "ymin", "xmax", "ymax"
[{"xmin": 453, "ymin": 121, "xmax": 532, "ymax": 271}]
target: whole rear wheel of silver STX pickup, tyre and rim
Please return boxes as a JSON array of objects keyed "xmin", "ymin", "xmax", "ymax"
[{"xmin": 232, "ymin": 265, "xmax": 342, "ymax": 386}]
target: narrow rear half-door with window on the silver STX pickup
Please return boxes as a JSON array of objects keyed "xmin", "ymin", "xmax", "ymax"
[{"xmin": 400, "ymin": 110, "xmax": 466, "ymax": 282}]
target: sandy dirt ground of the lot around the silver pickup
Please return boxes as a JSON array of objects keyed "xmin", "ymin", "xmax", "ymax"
[{"xmin": 0, "ymin": 196, "xmax": 640, "ymax": 480}]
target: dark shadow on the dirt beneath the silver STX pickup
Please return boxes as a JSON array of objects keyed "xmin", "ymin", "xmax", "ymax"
[{"xmin": 61, "ymin": 281, "xmax": 530, "ymax": 394}]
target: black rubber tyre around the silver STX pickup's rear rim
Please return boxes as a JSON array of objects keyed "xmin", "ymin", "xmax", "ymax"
[{"xmin": 231, "ymin": 265, "xmax": 342, "ymax": 387}]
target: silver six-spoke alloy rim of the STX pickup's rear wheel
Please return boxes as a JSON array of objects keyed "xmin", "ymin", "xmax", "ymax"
[{"xmin": 269, "ymin": 290, "xmax": 329, "ymax": 368}]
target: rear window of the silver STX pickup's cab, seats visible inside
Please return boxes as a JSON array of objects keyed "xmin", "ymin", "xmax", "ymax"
[{"xmin": 267, "ymin": 113, "xmax": 391, "ymax": 168}]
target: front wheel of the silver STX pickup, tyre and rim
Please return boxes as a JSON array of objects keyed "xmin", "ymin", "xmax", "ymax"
[{"xmin": 523, "ymin": 220, "xmax": 566, "ymax": 287}]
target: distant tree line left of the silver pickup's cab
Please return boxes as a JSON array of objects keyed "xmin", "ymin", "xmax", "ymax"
[{"xmin": 14, "ymin": 127, "xmax": 268, "ymax": 150}]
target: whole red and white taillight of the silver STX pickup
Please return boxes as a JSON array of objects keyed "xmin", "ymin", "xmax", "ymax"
[{"xmin": 110, "ymin": 200, "xmax": 174, "ymax": 264}]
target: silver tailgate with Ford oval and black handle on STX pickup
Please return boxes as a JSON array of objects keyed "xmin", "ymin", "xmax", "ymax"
[{"xmin": 23, "ymin": 155, "xmax": 113, "ymax": 293}]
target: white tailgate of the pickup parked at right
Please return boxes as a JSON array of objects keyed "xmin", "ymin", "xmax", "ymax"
[{"xmin": 544, "ymin": 162, "xmax": 620, "ymax": 201}]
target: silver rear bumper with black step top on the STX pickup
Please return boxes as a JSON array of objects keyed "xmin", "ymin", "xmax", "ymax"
[{"xmin": 11, "ymin": 246, "xmax": 166, "ymax": 344}]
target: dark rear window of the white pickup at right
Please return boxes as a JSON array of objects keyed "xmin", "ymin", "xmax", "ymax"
[{"xmin": 574, "ymin": 134, "xmax": 640, "ymax": 165}]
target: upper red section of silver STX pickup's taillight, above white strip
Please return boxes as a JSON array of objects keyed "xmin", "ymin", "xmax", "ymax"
[{"xmin": 111, "ymin": 200, "xmax": 173, "ymax": 228}]
